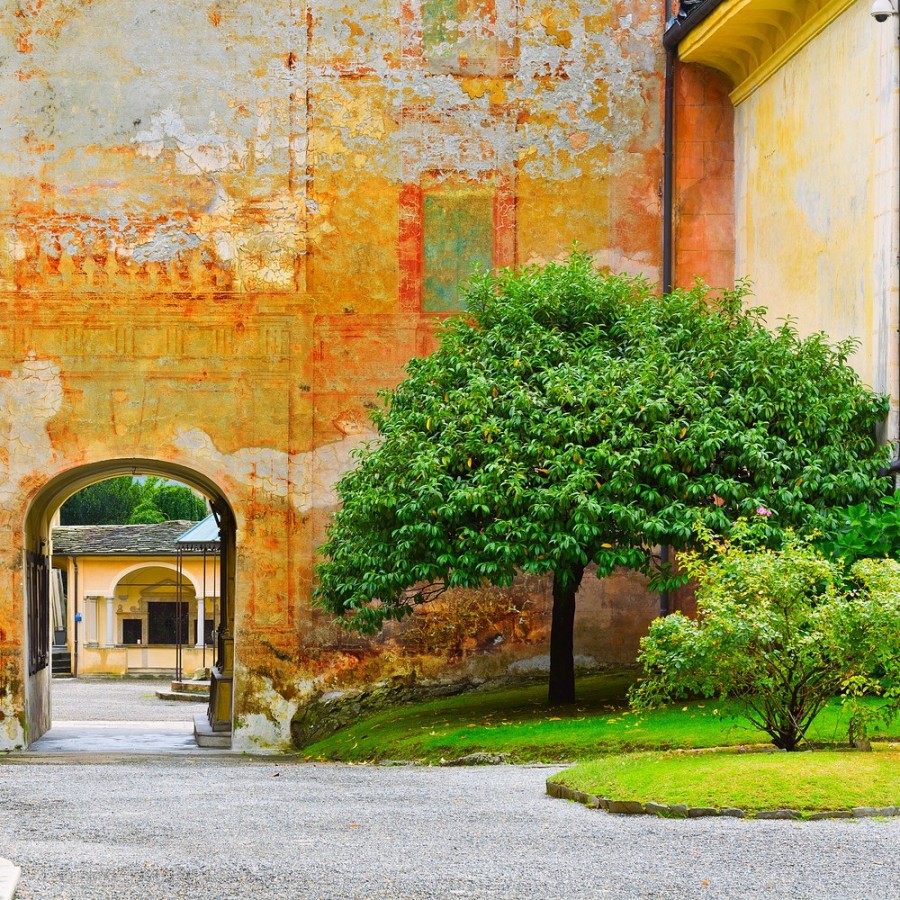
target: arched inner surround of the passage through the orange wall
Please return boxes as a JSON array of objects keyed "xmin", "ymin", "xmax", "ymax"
[{"xmin": 23, "ymin": 459, "xmax": 236, "ymax": 744}]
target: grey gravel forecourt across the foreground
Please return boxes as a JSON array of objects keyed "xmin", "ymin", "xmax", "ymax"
[{"xmin": 0, "ymin": 757, "xmax": 900, "ymax": 900}]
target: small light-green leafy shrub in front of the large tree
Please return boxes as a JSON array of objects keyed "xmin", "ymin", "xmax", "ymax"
[{"xmin": 632, "ymin": 534, "xmax": 900, "ymax": 750}]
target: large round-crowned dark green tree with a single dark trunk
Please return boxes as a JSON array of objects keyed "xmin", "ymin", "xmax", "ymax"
[{"xmin": 316, "ymin": 252, "xmax": 888, "ymax": 703}]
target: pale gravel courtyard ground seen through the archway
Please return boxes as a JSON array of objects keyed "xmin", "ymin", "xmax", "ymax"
[{"xmin": 51, "ymin": 678, "xmax": 205, "ymax": 724}]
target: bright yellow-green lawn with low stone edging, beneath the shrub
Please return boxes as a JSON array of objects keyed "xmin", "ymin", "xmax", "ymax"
[{"xmin": 550, "ymin": 744, "xmax": 900, "ymax": 812}]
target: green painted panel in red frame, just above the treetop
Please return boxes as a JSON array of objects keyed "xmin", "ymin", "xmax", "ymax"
[{"xmin": 422, "ymin": 191, "xmax": 494, "ymax": 312}]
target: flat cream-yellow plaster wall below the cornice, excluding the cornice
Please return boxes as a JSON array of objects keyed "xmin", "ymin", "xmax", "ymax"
[{"xmin": 735, "ymin": 0, "xmax": 898, "ymax": 408}]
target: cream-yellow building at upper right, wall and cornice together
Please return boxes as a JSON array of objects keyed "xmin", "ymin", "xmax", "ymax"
[{"xmin": 678, "ymin": 0, "xmax": 900, "ymax": 441}]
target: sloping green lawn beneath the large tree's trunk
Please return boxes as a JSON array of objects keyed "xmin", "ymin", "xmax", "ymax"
[{"xmin": 301, "ymin": 672, "xmax": 900, "ymax": 762}]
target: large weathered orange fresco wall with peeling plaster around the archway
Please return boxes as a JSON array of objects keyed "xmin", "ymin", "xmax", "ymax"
[{"xmin": 0, "ymin": 0, "xmax": 662, "ymax": 748}]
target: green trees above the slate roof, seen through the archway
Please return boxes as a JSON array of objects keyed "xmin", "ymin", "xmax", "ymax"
[{"xmin": 60, "ymin": 476, "xmax": 206, "ymax": 525}]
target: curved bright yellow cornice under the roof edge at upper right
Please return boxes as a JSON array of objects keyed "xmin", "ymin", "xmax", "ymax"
[{"xmin": 678, "ymin": 0, "xmax": 856, "ymax": 106}]
